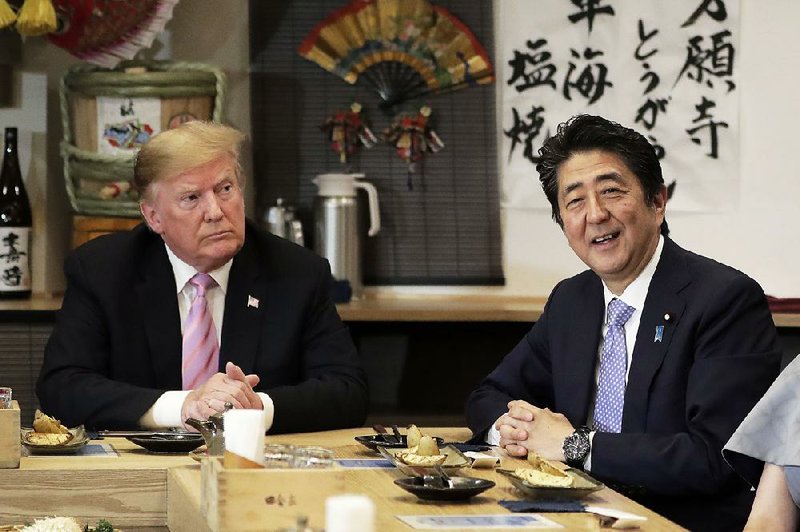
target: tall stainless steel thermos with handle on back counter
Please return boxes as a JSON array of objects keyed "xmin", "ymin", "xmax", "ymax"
[{"xmin": 312, "ymin": 174, "xmax": 381, "ymax": 299}]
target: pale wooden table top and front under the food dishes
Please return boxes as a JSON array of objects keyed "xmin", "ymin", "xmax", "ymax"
[{"xmin": 0, "ymin": 428, "xmax": 679, "ymax": 532}]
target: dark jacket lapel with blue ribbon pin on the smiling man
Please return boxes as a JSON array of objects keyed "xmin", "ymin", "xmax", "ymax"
[{"xmin": 622, "ymin": 239, "xmax": 691, "ymax": 432}]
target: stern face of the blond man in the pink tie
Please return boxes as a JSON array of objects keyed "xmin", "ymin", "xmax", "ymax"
[{"xmin": 141, "ymin": 155, "xmax": 244, "ymax": 272}]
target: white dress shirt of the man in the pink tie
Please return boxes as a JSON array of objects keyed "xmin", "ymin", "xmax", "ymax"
[{"xmin": 139, "ymin": 244, "xmax": 275, "ymax": 430}]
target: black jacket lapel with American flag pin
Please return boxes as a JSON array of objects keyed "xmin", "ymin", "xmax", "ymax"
[{"xmin": 219, "ymin": 235, "xmax": 266, "ymax": 373}]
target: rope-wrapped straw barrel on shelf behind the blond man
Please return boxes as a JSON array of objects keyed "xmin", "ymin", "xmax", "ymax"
[{"xmin": 60, "ymin": 61, "xmax": 225, "ymax": 217}]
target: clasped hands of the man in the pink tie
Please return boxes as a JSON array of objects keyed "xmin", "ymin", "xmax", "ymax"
[{"xmin": 181, "ymin": 362, "xmax": 264, "ymax": 431}]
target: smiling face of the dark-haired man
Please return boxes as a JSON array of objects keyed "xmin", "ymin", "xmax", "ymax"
[{"xmin": 558, "ymin": 150, "xmax": 667, "ymax": 295}]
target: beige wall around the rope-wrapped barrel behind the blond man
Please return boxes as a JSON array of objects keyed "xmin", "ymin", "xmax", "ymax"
[{"xmin": 14, "ymin": 0, "xmax": 252, "ymax": 292}]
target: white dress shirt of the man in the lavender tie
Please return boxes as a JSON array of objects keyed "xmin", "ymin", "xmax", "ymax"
[{"xmin": 486, "ymin": 235, "xmax": 664, "ymax": 471}]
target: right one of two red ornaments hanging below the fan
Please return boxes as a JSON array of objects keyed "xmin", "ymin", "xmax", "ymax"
[{"xmin": 384, "ymin": 105, "xmax": 444, "ymax": 190}]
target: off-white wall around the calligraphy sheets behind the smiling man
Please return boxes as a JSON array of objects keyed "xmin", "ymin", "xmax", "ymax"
[{"xmin": 495, "ymin": 0, "xmax": 800, "ymax": 297}]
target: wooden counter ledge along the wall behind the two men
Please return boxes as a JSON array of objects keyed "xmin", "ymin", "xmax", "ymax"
[{"xmin": 6, "ymin": 295, "xmax": 800, "ymax": 328}]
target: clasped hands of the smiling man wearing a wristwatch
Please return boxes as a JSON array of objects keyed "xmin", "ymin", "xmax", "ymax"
[{"xmin": 495, "ymin": 400, "xmax": 575, "ymax": 462}]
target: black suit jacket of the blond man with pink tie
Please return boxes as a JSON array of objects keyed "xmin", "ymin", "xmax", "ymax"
[{"xmin": 37, "ymin": 221, "xmax": 368, "ymax": 432}]
